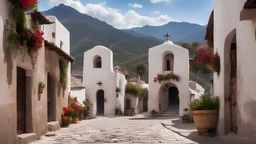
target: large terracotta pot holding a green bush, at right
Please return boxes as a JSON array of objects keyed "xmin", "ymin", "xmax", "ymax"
[{"xmin": 192, "ymin": 110, "xmax": 217, "ymax": 134}]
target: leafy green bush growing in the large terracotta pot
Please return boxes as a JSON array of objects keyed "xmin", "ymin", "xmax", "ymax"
[{"xmin": 189, "ymin": 95, "xmax": 219, "ymax": 111}]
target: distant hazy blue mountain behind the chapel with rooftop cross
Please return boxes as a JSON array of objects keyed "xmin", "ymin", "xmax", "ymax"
[{"xmin": 126, "ymin": 22, "xmax": 206, "ymax": 43}]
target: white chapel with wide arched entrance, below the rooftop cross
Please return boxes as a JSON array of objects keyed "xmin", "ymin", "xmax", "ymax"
[{"xmin": 148, "ymin": 41, "xmax": 190, "ymax": 116}]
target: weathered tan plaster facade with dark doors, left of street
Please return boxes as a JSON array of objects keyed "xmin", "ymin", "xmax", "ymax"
[{"xmin": 0, "ymin": 0, "xmax": 74, "ymax": 144}]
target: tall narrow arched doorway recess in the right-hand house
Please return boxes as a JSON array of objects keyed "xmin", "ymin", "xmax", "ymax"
[{"xmin": 224, "ymin": 29, "xmax": 237, "ymax": 133}]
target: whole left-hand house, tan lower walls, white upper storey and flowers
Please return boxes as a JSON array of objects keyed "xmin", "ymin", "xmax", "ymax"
[{"xmin": 0, "ymin": 0, "xmax": 74, "ymax": 144}]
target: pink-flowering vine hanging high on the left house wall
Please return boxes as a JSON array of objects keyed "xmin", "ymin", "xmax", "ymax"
[{"xmin": 8, "ymin": 0, "xmax": 44, "ymax": 68}]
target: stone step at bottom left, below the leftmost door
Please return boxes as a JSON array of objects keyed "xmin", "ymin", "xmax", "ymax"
[{"xmin": 17, "ymin": 133, "xmax": 37, "ymax": 144}]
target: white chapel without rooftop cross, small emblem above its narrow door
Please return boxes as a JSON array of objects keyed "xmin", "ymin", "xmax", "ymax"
[{"xmin": 83, "ymin": 46, "xmax": 126, "ymax": 117}]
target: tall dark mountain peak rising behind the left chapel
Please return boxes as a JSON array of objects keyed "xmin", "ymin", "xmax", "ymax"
[{"xmin": 43, "ymin": 4, "xmax": 163, "ymax": 72}]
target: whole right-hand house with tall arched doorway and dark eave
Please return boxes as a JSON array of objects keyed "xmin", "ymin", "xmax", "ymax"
[{"xmin": 205, "ymin": 0, "xmax": 256, "ymax": 139}]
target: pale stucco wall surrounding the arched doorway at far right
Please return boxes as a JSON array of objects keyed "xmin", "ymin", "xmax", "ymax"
[{"xmin": 214, "ymin": 0, "xmax": 256, "ymax": 139}]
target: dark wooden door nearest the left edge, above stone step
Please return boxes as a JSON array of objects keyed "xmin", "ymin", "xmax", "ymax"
[{"xmin": 17, "ymin": 67, "xmax": 26, "ymax": 134}]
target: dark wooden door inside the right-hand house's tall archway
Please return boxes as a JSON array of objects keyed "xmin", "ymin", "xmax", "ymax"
[{"xmin": 230, "ymin": 44, "xmax": 237, "ymax": 133}]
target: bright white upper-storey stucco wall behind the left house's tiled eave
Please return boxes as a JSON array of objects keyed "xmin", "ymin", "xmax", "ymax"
[{"xmin": 42, "ymin": 16, "xmax": 71, "ymax": 91}]
